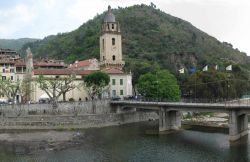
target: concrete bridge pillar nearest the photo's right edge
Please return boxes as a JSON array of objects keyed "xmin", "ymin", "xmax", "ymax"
[{"xmin": 229, "ymin": 110, "xmax": 248, "ymax": 141}]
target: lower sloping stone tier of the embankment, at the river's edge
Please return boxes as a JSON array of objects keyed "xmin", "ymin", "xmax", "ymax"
[{"xmin": 0, "ymin": 112, "xmax": 158, "ymax": 130}]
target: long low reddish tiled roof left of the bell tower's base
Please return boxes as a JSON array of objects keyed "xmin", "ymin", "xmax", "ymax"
[{"xmin": 34, "ymin": 69, "xmax": 94, "ymax": 75}]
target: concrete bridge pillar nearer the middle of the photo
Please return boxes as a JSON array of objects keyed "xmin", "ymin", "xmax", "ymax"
[{"xmin": 159, "ymin": 108, "xmax": 181, "ymax": 131}]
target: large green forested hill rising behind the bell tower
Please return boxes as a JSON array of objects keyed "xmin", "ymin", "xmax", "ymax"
[{"xmin": 22, "ymin": 5, "xmax": 250, "ymax": 72}]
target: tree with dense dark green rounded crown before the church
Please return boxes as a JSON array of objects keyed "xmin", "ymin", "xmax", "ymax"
[{"xmin": 84, "ymin": 71, "xmax": 110, "ymax": 113}]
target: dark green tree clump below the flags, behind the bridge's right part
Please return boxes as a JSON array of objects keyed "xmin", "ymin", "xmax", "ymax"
[{"xmin": 183, "ymin": 70, "xmax": 249, "ymax": 100}]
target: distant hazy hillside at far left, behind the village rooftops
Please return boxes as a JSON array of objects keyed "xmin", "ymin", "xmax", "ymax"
[{"xmin": 0, "ymin": 38, "xmax": 38, "ymax": 51}]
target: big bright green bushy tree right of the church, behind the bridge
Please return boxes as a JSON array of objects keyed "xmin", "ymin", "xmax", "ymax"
[{"xmin": 136, "ymin": 70, "xmax": 180, "ymax": 101}]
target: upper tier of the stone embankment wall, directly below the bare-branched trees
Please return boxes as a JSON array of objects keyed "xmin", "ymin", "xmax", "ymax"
[{"xmin": 0, "ymin": 100, "xmax": 111, "ymax": 117}]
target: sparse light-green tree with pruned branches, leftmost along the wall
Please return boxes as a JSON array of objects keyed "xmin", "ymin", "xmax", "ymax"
[{"xmin": 0, "ymin": 79, "xmax": 21, "ymax": 108}]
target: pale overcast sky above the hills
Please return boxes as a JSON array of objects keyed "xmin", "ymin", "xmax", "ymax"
[{"xmin": 0, "ymin": 0, "xmax": 250, "ymax": 55}]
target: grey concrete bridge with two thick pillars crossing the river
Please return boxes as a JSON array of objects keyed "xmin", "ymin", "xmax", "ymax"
[{"xmin": 110, "ymin": 101, "xmax": 250, "ymax": 141}]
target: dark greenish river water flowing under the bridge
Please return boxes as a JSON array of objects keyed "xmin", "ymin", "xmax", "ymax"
[{"xmin": 0, "ymin": 121, "xmax": 250, "ymax": 162}]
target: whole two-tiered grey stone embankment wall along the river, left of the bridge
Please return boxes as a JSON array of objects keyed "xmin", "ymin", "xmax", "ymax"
[{"xmin": 0, "ymin": 100, "xmax": 158, "ymax": 129}]
